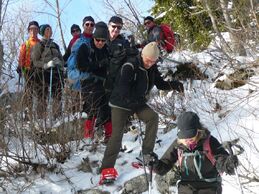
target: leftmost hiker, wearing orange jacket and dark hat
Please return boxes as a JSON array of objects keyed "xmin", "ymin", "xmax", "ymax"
[{"xmin": 16, "ymin": 21, "xmax": 40, "ymax": 118}]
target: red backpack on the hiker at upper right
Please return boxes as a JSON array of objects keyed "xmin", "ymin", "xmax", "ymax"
[{"xmin": 160, "ymin": 24, "xmax": 175, "ymax": 53}]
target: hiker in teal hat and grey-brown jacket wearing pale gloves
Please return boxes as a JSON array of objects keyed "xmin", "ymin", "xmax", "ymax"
[{"xmin": 32, "ymin": 24, "xmax": 64, "ymax": 118}]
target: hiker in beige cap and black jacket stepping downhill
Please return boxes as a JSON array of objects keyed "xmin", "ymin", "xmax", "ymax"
[{"xmin": 100, "ymin": 42, "xmax": 183, "ymax": 184}]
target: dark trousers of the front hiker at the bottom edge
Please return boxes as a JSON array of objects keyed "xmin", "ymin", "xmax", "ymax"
[{"xmin": 178, "ymin": 182, "xmax": 222, "ymax": 194}]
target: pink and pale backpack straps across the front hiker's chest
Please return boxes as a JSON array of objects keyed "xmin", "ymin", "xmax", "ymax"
[{"xmin": 177, "ymin": 135, "xmax": 218, "ymax": 182}]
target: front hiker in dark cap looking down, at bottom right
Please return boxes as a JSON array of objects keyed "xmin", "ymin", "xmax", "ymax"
[{"xmin": 152, "ymin": 112, "xmax": 238, "ymax": 194}]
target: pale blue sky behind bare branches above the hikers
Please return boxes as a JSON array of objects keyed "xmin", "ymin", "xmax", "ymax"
[{"xmin": 13, "ymin": 0, "xmax": 154, "ymax": 50}]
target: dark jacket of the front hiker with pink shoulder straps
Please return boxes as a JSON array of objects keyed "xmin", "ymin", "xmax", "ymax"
[{"xmin": 154, "ymin": 130, "xmax": 234, "ymax": 189}]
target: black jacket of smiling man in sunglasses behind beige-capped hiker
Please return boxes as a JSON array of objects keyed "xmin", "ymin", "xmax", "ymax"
[{"xmin": 105, "ymin": 35, "xmax": 130, "ymax": 91}]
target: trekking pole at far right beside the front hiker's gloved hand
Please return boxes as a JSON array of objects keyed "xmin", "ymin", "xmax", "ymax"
[{"xmin": 222, "ymin": 139, "xmax": 244, "ymax": 194}]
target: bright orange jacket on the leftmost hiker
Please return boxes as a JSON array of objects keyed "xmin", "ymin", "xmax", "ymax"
[{"xmin": 19, "ymin": 37, "xmax": 40, "ymax": 69}]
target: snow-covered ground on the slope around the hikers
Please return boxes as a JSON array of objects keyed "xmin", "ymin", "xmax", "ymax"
[{"xmin": 0, "ymin": 42, "xmax": 259, "ymax": 194}]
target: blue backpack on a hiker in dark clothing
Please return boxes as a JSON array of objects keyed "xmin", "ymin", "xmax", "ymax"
[{"xmin": 67, "ymin": 34, "xmax": 91, "ymax": 91}]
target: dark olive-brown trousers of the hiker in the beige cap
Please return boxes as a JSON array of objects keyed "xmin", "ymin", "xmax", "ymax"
[{"xmin": 101, "ymin": 105, "xmax": 158, "ymax": 170}]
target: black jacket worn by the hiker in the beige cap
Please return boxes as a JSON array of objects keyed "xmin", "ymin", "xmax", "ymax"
[{"xmin": 110, "ymin": 55, "xmax": 183, "ymax": 111}]
